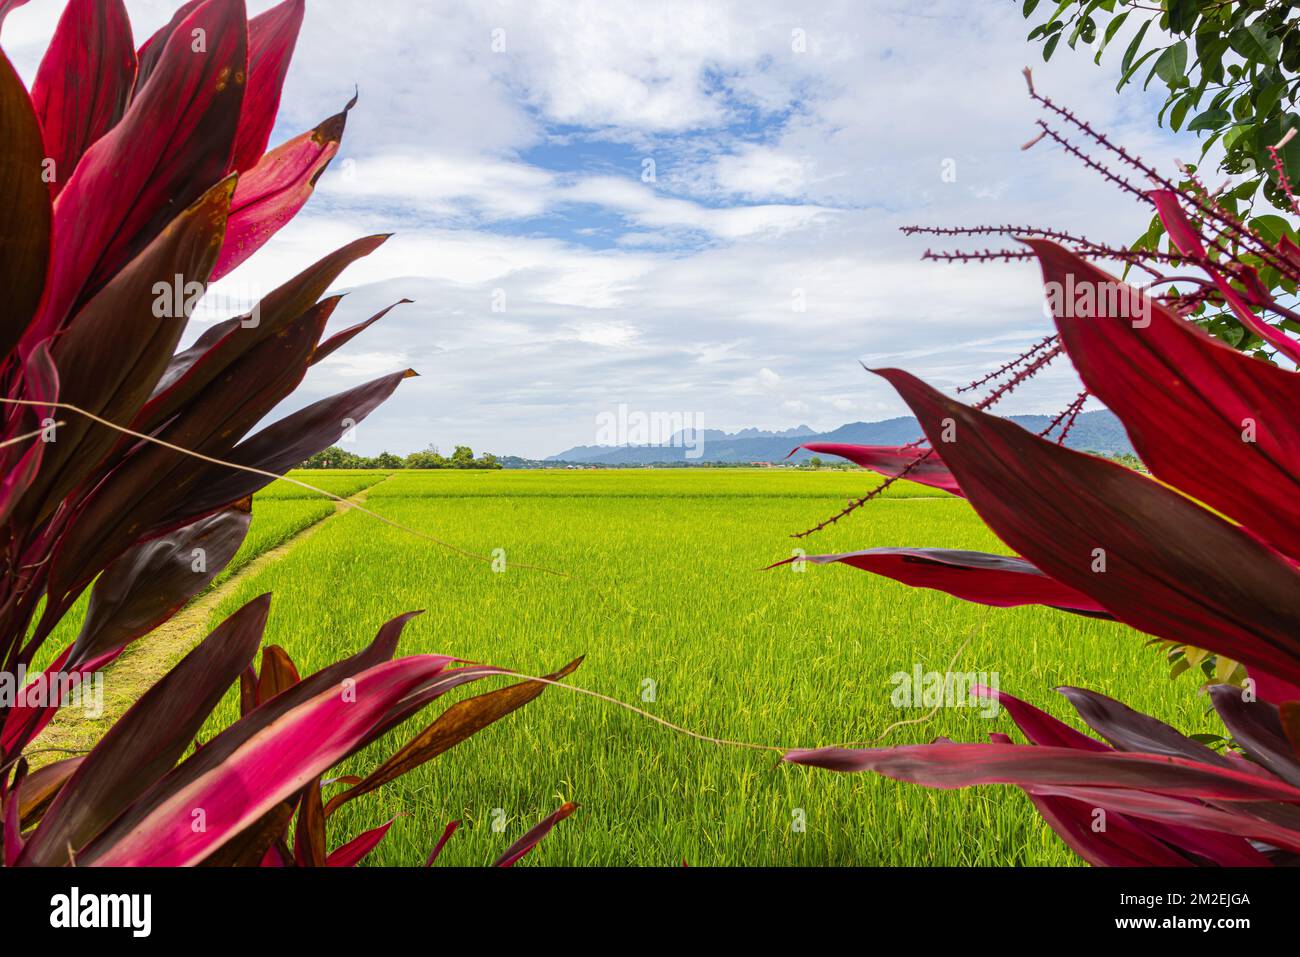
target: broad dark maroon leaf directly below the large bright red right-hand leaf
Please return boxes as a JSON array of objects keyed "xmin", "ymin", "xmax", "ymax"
[{"xmin": 879, "ymin": 369, "xmax": 1300, "ymax": 696}]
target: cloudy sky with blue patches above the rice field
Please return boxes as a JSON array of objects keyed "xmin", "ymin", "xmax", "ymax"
[{"xmin": 4, "ymin": 0, "xmax": 1197, "ymax": 455}]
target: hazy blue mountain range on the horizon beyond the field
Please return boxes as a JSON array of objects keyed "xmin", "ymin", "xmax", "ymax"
[{"xmin": 546, "ymin": 410, "xmax": 1134, "ymax": 465}]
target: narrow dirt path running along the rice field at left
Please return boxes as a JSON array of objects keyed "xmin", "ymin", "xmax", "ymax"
[{"xmin": 27, "ymin": 476, "xmax": 391, "ymax": 767}]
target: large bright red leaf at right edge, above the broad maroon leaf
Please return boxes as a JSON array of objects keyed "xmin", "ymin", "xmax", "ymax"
[{"xmin": 1026, "ymin": 239, "xmax": 1300, "ymax": 558}]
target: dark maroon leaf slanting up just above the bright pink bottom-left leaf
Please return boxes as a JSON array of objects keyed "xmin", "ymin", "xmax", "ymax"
[{"xmin": 23, "ymin": 594, "xmax": 270, "ymax": 866}]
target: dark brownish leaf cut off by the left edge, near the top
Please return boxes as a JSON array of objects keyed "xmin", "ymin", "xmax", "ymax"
[{"xmin": 0, "ymin": 47, "xmax": 53, "ymax": 355}]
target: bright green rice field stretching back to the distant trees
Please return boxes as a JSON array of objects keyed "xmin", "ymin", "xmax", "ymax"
[{"xmin": 180, "ymin": 469, "xmax": 1218, "ymax": 866}]
